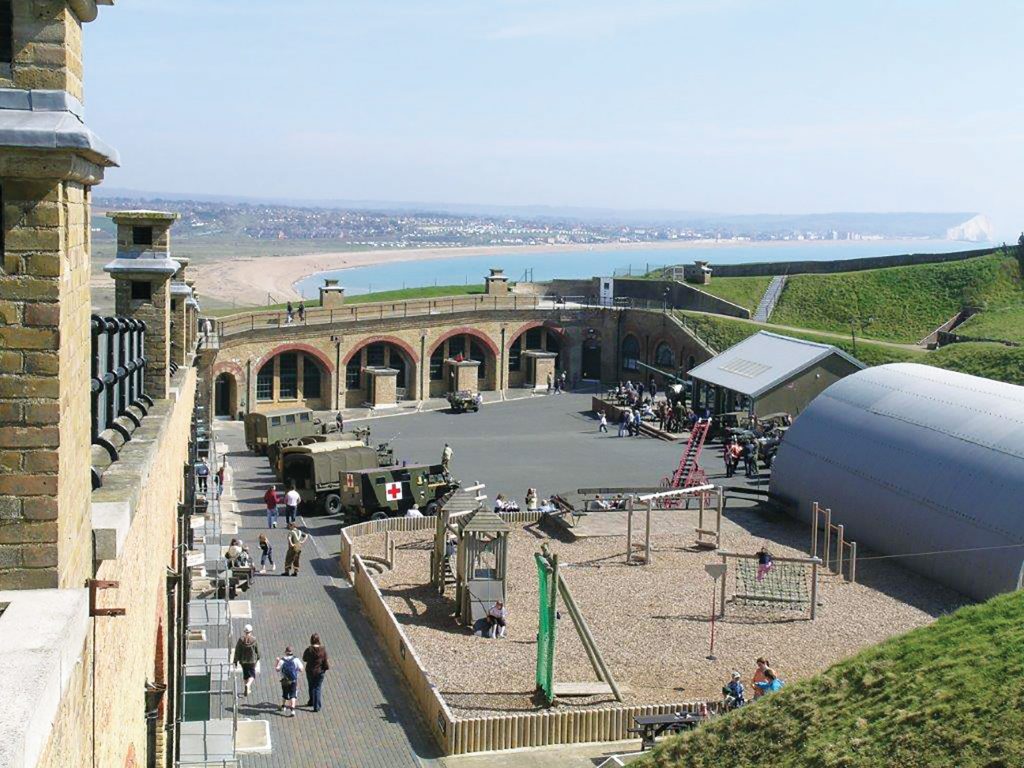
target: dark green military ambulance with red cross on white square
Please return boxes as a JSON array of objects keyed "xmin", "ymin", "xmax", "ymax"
[{"xmin": 339, "ymin": 464, "xmax": 459, "ymax": 520}]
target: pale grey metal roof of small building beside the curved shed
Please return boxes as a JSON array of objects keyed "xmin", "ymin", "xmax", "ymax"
[{"xmin": 689, "ymin": 331, "xmax": 864, "ymax": 398}]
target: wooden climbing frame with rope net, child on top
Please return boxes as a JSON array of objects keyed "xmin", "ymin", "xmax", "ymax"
[{"xmin": 718, "ymin": 550, "xmax": 821, "ymax": 620}]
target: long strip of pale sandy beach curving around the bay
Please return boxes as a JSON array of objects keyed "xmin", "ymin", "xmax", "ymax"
[{"xmin": 193, "ymin": 238, "xmax": 983, "ymax": 305}]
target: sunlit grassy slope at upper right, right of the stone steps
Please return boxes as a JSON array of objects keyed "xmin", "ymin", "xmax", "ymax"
[{"xmin": 770, "ymin": 253, "xmax": 1024, "ymax": 343}]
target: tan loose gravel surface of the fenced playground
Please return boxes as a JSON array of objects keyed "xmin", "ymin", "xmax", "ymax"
[{"xmin": 356, "ymin": 507, "xmax": 965, "ymax": 716}]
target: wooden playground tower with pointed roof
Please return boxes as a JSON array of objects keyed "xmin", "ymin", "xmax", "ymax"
[{"xmin": 455, "ymin": 508, "xmax": 512, "ymax": 627}]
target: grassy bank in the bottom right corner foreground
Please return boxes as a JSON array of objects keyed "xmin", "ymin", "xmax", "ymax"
[{"xmin": 631, "ymin": 592, "xmax": 1024, "ymax": 768}]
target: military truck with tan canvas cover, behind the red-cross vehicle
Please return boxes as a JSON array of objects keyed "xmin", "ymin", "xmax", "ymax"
[{"xmin": 278, "ymin": 440, "xmax": 394, "ymax": 514}]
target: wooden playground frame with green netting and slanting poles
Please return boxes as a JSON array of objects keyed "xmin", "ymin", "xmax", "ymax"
[{"xmin": 535, "ymin": 544, "xmax": 623, "ymax": 705}]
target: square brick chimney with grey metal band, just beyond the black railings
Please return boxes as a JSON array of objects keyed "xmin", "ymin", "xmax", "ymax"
[{"xmin": 103, "ymin": 211, "xmax": 186, "ymax": 399}]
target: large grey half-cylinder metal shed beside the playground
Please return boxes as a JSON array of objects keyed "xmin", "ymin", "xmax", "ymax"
[{"xmin": 771, "ymin": 364, "xmax": 1024, "ymax": 600}]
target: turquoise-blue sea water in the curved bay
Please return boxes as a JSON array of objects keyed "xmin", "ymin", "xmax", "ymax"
[{"xmin": 295, "ymin": 240, "xmax": 994, "ymax": 299}]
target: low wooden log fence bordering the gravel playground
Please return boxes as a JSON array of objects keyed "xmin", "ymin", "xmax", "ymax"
[{"xmin": 341, "ymin": 512, "xmax": 720, "ymax": 755}]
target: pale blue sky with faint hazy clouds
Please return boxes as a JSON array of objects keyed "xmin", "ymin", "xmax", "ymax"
[{"xmin": 85, "ymin": 0, "xmax": 1024, "ymax": 239}]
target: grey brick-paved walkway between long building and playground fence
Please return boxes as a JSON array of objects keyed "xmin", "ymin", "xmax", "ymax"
[{"xmin": 217, "ymin": 422, "xmax": 439, "ymax": 768}]
